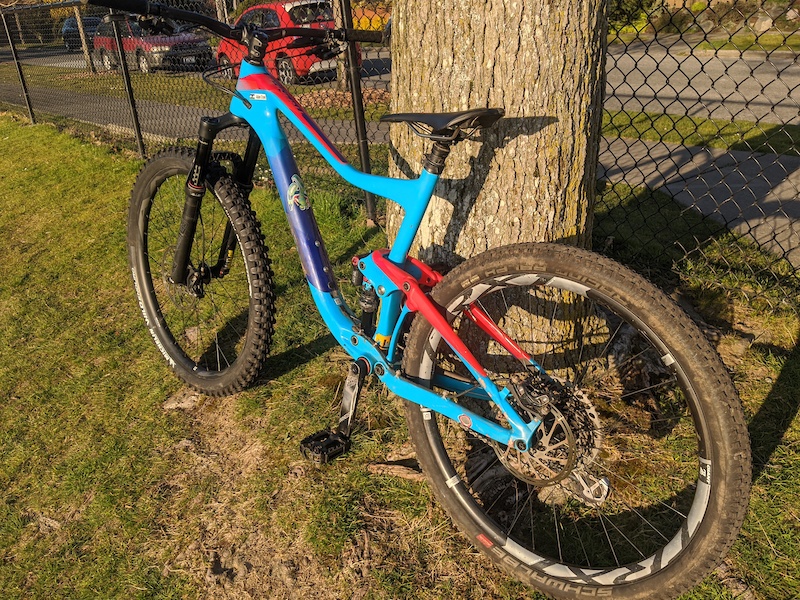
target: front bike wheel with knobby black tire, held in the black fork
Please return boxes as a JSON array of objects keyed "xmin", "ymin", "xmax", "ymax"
[{"xmin": 128, "ymin": 149, "xmax": 274, "ymax": 396}]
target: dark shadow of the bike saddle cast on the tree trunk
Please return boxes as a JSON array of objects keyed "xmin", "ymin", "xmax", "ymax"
[{"xmin": 389, "ymin": 116, "xmax": 558, "ymax": 267}]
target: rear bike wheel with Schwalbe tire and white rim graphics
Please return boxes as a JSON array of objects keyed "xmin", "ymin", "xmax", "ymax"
[{"xmin": 403, "ymin": 244, "xmax": 751, "ymax": 599}]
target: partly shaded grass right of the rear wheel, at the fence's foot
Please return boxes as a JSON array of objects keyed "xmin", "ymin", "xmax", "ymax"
[{"xmin": 593, "ymin": 179, "xmax": 800, "ymax": 599}]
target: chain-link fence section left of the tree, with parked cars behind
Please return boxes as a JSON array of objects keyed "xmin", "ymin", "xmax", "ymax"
[{"xmin": 0, "ymin": 0, "xmax": 391, "ymax": 151}]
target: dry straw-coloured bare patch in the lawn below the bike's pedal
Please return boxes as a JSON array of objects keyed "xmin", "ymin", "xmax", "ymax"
[{"xmin": 149, "ymin": 391, "xmax": 506, "ymax": 600}]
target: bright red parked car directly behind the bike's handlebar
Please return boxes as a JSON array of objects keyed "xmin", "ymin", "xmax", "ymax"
[{"xmin": 217, "ymin": 0, "xmax": 344, "ymax": 85}]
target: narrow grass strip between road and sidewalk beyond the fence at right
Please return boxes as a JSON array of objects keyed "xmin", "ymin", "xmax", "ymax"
[{"xmin": 601, "ymin": 110, "xmax": 800, "ymax": 156}]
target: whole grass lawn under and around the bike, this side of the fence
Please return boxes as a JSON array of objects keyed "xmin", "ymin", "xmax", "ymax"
[{"xmin": 0, "ymin": 115, "xmax": 800, "ymax": 599}]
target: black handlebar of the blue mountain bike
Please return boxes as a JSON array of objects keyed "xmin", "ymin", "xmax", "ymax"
[{"xmin": 81, "ymin": 0, "xmax": 383, "ymax": 43}]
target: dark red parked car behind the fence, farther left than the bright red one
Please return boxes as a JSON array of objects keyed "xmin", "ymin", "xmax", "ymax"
[{"xmin": 94, "ymin": 21, "xmax": 211, "ymax": 73}]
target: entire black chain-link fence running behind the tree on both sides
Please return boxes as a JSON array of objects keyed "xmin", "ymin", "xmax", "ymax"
[{"xmin": 0, "ymin": 0, "xmax": 800, "ymax": 307}]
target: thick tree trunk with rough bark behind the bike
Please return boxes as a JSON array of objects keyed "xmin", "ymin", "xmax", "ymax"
[{"xmin": 388, "ymin": 0, "xmax": 606, "ymax": 265}]
